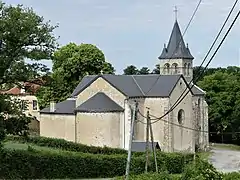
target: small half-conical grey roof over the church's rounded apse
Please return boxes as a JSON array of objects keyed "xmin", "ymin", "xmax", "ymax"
[{"xmin": 76, "ymin": 92, "xmax": 124, "ymax": 112}]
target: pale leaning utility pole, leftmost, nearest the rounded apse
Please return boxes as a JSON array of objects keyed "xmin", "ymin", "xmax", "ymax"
[{"xmin": 125, "ymin": 101, "xmax": 138, "ymax": 180}]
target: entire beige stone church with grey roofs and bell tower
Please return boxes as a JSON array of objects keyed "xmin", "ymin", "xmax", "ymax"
[{"xmin": 40, "ymin": 21, "xmax": 208, "ymax": 152}]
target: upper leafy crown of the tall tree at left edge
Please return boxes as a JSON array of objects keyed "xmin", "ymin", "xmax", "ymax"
[{"xmin": 0, "ymin": 2, "xmax": 57, "ymax": 84}]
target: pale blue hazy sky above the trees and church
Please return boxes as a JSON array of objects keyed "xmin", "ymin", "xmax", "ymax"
[{"xmin": 4, "ymin": 0, "xmax": 240, "ymax": 74}]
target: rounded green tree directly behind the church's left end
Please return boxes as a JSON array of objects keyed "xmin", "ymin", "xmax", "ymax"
[{"xmin": 38, "ymin": 43, "xmax": 115, "ymax": 108}]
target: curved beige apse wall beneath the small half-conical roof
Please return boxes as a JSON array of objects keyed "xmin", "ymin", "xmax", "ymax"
[{"xmin": 76, "ymin": 113, "xmax": 124, "ymax": 148}]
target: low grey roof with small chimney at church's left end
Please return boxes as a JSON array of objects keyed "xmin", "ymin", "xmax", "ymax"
[{"xmin": 40, "ymin": 99, "xmax": 76, "ymax": 114}]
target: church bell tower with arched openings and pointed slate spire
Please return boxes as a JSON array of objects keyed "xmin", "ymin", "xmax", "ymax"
[{"xmin": 158, "ymin": 7, "xmax": 194, "ymax": 82}]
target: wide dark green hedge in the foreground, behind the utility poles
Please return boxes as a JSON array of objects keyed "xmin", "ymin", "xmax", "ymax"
[{"xmin": 0, "ymin": 148, "xmax": 195, "ymax": 179}]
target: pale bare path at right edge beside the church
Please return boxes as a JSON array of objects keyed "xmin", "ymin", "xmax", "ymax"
[{"xmin": 209, "ymin": 148, "xmax": 240, "ymax": 173}]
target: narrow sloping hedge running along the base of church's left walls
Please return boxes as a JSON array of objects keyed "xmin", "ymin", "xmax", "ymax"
[{"xmin": 6, "ymin": 136, "xmax": 127, "ymax": 154}]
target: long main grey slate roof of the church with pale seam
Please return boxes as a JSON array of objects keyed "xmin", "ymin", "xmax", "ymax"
[{"xmin": 71, "ymin": 74, "xmax": 182, "ymax": 97}]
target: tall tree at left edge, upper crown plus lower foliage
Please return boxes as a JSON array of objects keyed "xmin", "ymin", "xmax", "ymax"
[{"xmin": 0, "ymin": 2, "xmax": 57, "ymax": 143}]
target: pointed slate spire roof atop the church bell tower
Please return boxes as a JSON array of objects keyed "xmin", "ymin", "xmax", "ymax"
[{"xmin": 158, "ymin": 21, "xmax": 194, "ymax": 59}]
